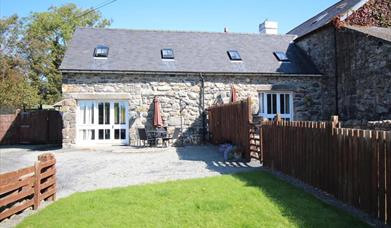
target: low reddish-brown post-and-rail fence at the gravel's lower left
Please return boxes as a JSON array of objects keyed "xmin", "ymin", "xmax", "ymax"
[{"xmin": 0, "ymin": 153, "xmax": 56, "ymax": 221}]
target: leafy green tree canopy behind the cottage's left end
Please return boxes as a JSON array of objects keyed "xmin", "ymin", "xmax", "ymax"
[{"xmin": 0, "ymin": 4, "xmax": 111, "ymax": 107}]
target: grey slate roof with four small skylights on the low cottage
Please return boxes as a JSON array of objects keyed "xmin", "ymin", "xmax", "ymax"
[{"xmin": 60, "ymin": 28, "xmax": 318, "ymax": 74}]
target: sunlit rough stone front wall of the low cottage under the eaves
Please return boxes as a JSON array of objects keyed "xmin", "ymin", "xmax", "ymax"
[{"xmin": 62, "ymin": 73, "xmax": 328, "ymax": 146}]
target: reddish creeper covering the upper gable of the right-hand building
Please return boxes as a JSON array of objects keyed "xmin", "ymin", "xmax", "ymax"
[{"xmin": 346, "ymin": 0, "xmax": 391, "ymax": 27}]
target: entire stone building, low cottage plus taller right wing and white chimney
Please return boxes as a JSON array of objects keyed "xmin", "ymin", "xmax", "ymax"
[{"xmin": 60, "ymin": 0, "xmax": 391, "ymax": 146}]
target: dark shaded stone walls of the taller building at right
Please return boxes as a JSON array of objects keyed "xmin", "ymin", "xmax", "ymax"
[{"xmin": 296, "ymin": 25, "xmax": 391, "ymax": 121}]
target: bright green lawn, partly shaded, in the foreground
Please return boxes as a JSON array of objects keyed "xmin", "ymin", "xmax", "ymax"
[{"xmin": 19, "ymin": 171, "xmax": 365, "ymax": 227}]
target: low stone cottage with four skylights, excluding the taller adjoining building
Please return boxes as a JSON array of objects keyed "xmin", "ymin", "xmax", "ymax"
[{"xmin": 61, "ymin": 28, "xmax": 324, "ymax": 146}]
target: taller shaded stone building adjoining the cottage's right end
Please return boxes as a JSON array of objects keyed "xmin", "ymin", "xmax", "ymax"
[{"xmin": 289, "ymin": 0, "xmax": 391, "ymax": 121}]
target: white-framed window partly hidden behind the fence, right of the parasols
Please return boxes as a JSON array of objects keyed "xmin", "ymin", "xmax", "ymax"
[{"xmin": 259, "ymin": 92, "xmax": 293, "ymax": 121}]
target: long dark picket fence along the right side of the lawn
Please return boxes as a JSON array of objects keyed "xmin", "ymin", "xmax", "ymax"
[{"xmin": 260, "ymin": 117, "xmax": 391, "ymax": 224}]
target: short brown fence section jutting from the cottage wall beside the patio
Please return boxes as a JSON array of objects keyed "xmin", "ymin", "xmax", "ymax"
[{"xmin": 208, "ymin": 98, "xmax": 252, "ymax": 160}]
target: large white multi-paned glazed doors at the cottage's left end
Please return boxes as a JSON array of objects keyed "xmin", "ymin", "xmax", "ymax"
[{"xmin": 76, "ymin": 100, "xmax": 129, "ymax": 144}]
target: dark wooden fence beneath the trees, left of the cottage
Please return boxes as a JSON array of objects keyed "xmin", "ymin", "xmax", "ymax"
[{"xmin": 0, "ymin": 110, "xmax": 62, "ymax": 144}]
